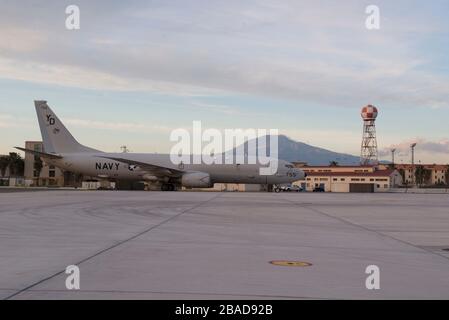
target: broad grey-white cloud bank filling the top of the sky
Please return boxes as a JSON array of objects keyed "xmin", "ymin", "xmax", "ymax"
[{"xmin": 0, "ymin": 0, "xmax": 449, "ymax": 110}]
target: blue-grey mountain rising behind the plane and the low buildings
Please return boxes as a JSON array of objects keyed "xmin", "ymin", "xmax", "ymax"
[{"xmin": 234, "ymin": 135, "xmax": 360, "ymax": 165}]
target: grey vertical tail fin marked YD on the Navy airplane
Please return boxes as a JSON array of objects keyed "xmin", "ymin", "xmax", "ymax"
[{"xmin": 34, "ymin": 100, "xmax": 99, "ymax": 154}]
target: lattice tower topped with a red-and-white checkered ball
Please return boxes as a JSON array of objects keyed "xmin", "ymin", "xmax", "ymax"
[{"xmin": 360, "ymin": 104, "xmax": 378, "ymax": 165}]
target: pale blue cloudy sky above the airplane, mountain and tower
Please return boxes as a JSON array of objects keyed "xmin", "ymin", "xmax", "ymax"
[{"xmin": 0, "ymin": 0, "xmax": 449, "ymax": 163}]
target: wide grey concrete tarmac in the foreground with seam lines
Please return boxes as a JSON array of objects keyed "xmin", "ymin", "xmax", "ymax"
[{"xmin": 0, "ymin": 190, "xmax": 449, "ymax": 299}]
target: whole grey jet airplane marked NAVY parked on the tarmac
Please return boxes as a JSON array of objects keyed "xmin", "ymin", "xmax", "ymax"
[{"xmin": 16, "ymin": 101, "xmax": 305, "ymax": 191}]
